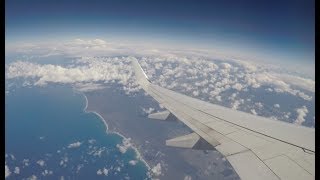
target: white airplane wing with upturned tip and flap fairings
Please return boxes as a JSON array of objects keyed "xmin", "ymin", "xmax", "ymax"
[{"xmin": 132, "ymin": 60, "xmax": 315, "ymax": 180}]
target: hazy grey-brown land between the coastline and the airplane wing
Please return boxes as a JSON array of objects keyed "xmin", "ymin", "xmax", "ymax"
[{"xmin": 85, "ymin": 88, "xmax": 239, "ymax": 179}]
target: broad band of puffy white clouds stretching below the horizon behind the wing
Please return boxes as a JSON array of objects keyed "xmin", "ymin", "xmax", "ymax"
[{"xmin": 5, "ymin": 39, "xmax": 315, "ymax": 127}]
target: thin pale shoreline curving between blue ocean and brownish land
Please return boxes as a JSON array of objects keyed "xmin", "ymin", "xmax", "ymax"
[{"xmin": 76, "ymin": 90, "xmax": 152, "ymax": 172}]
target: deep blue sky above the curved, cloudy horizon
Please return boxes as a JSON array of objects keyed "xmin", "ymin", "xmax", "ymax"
[{"xmin": 5, "ymin": 0, "xmax": 315, "ymax": 64}]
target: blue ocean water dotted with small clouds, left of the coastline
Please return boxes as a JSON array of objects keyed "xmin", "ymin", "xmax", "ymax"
[{"xmin": 5, "ymin": 86, "xmax": 148, "ymax": 179}]
